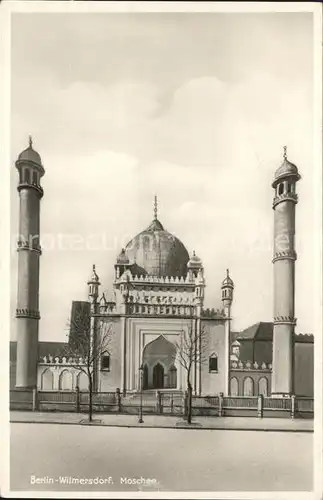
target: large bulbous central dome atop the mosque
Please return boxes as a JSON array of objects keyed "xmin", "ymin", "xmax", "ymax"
[{"xmin": 126, "ymin": 218, "xmax": 189, "ymax": 277}]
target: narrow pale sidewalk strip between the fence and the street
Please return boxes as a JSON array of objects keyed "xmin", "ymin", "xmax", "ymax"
[{"xmin": 10, "ymin": 411, "xmax": 314, "ymax": 432}]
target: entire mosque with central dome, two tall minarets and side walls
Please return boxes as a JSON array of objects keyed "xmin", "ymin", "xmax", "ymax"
[{"xmin": 11, "ymin": 140, "xmax": 314, "ymax": 397}]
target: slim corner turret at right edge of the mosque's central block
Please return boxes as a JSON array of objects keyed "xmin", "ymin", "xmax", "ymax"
[{"xmin": 221, "ymin": 269, "xmax": 234, "ymax": 396}]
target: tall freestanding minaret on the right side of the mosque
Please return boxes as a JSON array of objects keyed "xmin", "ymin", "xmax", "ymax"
[{"xmin": 271, "ymin": 147, "xmax": 300, "ymax": 397}]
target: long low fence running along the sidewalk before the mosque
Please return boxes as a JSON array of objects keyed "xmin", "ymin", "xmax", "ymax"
[{"xmin": 10, "ymin": 389, "xmax": 314, "ymax": 418}]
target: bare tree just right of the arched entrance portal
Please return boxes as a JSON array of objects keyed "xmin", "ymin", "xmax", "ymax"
[{"xmin": 175, "ymin": 323, "xmax": 208, "ymax": 424}]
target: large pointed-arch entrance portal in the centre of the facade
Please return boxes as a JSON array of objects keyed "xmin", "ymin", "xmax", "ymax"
[{"xmin": 143, "ymin": 335, "xmax": 177, "ymax": 389}]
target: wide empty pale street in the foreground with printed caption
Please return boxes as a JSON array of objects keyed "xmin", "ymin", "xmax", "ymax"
[{"xmin": 11, "ymin": 423, "xmax": 313, "ymax": 492}]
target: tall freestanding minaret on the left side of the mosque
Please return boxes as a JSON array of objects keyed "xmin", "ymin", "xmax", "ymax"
[{"xmin": 16, "ymin": 137, "xmax": 45, "ymax": 388}]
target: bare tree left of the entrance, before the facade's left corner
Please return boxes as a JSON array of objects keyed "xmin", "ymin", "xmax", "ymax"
[{"xmin": 64, "ymin": 309, "xmax": 112, "ymax": 422}]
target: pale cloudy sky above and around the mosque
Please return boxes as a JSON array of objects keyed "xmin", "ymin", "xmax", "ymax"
[{"xmin": 11, "ymin": 13, "xmax": 315, "ymax": 341}]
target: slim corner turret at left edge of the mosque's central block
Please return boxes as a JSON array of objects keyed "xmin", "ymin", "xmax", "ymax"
[{"xmin": 87, "ymin": 264, "xmax": 101, "ymax": 392}]
